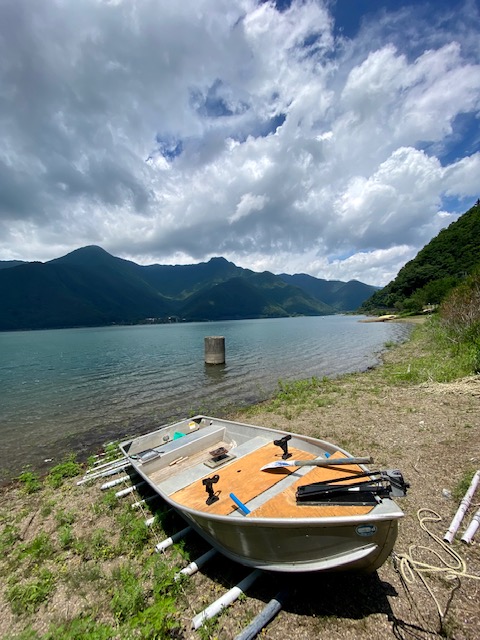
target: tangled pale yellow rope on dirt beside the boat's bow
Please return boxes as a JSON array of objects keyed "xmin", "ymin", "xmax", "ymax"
[{"xmin": 393, "ymin": 509, "xmax": 480, "ymax": 620}]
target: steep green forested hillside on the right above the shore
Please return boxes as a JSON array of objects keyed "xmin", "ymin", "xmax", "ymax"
[{"xmin": 361, "ymin": 201, "xmax": 480, "ymax": 313}]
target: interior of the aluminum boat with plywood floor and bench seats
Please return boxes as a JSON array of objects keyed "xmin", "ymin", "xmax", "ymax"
[{"xmin": 122, "ymin": 417, "xmax": 398, "ymax": 519}]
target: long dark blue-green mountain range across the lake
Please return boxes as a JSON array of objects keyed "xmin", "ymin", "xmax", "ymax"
[{"xmin": 0, "ymin": 246, "xmax": 378, "ymax": 331}]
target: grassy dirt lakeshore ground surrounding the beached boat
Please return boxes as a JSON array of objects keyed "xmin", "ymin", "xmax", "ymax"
[{"xmin": 0, "ymin": 318, "xmax": 480, "ymax": 640}]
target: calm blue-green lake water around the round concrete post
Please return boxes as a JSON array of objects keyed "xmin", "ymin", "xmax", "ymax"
[{"xmin": 0, "ymin": 316, "xmax": 410, "ymax": 482}]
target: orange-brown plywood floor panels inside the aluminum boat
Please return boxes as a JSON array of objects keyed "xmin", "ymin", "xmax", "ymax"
[{"xmin": 170, "ymin": 443, "xmax": 372, "ymax": 518}]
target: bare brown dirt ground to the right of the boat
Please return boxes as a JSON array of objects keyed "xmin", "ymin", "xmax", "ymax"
[{"xmin": 225, "ymin": 338, "xmax": 480, "ymax": 640}]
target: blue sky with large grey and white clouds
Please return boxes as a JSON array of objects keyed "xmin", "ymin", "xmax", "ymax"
[{"xmin": 0, "ymin": 0, "xmax": 480, "ymax": 285}]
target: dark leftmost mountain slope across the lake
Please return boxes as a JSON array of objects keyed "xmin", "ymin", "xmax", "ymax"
[{"xmin": 0, "ymin": 248, "xmax": 171, "ymax": 331}]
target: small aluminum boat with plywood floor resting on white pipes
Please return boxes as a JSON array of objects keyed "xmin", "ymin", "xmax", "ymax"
[{"xmin": 120, "ymin": 415, "xmax": 408, "ymax": 572}]
